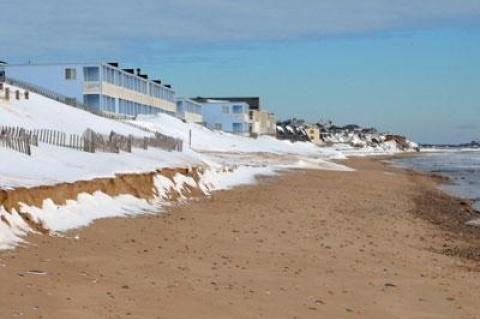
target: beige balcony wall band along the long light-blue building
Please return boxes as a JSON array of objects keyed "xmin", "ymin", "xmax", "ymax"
[{"xmin": 83, "ymin": 82, "xmax": 177, "ymax": 113}]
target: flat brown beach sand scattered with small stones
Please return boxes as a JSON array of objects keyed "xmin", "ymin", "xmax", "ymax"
[{"xmin": 0, "ymin": 159, "xmax": 480, "ymax": 319}]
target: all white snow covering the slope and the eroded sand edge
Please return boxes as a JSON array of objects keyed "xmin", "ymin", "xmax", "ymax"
[{"xmin": 0, "ymin": 84, "xmax": 416, "ymax": 249}]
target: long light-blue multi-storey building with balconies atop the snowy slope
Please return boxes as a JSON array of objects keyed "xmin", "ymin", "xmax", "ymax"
[{"xmin": 0, "ymin": 62, "xmax": 176, "ymax": 117}]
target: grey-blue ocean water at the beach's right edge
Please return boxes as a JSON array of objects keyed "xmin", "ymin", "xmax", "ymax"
[{"xmin": 393, "ymin": 150, "xmax": 480, "ymax": 210}]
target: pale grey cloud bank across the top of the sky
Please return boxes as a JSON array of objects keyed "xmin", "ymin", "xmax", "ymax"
[{"xmin": 0, "ymin": 0, "xmax": 480, "ymax": 57}]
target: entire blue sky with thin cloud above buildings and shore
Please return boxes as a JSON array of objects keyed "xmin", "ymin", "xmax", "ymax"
[{"xmin": 0, "ymin": 0, "xmax": 480, "ymax": 143}]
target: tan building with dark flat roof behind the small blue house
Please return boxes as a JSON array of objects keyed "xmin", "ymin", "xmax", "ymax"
[{"xmin": 193, "ymin": 97, "xmax": 276, "ymax": 136}]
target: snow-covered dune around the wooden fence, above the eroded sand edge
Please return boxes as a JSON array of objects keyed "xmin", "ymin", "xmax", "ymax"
[{"xmin": 0, "ymin": 86, "xmax": 343, "ymax": 188}]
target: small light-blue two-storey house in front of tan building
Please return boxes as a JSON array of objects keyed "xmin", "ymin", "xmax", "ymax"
[{"xmin": 192, "ymin": 98, "xmax": 251, "ymax": 136}]
